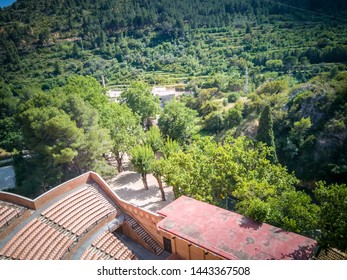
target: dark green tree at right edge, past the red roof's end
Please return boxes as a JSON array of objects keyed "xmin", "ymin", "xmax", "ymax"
[{"xmin": 314, "ymin": 182, "xmax": 347, "ymax": 251}]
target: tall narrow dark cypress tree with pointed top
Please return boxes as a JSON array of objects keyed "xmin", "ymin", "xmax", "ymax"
[{"xmin": 256, "ymin": 105, "xmax": 278, "ymax": 163}]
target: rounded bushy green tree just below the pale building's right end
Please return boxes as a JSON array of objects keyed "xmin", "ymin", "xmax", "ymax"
[{"xmin": 158, "ymin": 100, "xmax": 197, "ymax": 143}]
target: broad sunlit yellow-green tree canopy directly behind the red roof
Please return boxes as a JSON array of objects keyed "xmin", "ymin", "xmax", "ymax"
[{"xmin": 163, "ymin": 137, "xmax": 318, "ymax": 234}]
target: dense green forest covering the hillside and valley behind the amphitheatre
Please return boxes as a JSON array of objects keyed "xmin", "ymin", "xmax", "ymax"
[{"xmin": 0, "ymin": 0, "xmax": 347, "ymax": 251}]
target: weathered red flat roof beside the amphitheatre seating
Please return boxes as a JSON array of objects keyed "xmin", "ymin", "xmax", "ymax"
[{"xmin": 158, "ymin": 196, "xmax": 317, "ymax": 260}]
